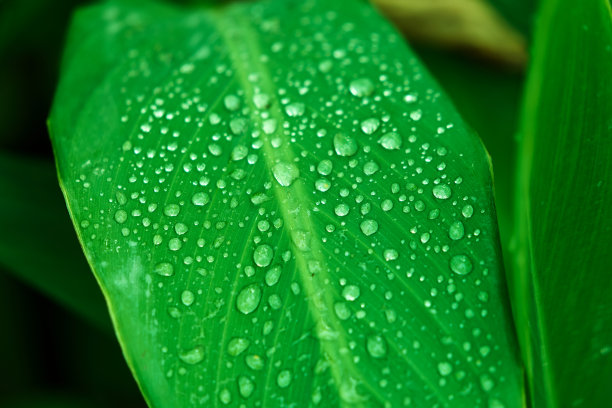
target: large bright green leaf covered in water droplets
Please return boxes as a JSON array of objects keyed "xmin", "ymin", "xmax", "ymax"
[{"xmin": 50, "ymin": 0, "xmax": 522, "ymax": 407}]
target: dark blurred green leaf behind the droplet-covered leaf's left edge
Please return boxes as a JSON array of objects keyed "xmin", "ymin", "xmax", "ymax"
[{"xmin": 0, "ymin": 152, "xmax": 111, "ymax": 330}]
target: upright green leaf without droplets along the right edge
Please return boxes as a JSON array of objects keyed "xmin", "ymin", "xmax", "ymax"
[{"xmin": 512, "ymin": 0, "xmax": 612, "ymax": 407}]
